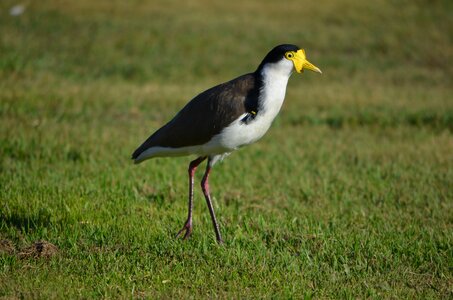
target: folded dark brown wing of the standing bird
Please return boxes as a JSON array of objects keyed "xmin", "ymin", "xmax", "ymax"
[{"xmin": 132, "ymin": 74, "xmax": 259, "ymax": 159}]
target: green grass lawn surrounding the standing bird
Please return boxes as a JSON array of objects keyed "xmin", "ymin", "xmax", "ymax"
[{"xmin": 0, "ymin": 0, "xmax": 453, "ymax": 299}]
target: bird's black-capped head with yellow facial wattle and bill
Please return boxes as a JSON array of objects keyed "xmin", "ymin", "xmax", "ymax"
[{"xmin": 258, "ymin": 44, "xmax": 322, "ymax": 74}]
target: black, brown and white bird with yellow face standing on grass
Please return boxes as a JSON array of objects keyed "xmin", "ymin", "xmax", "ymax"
[{"xmin": 132, "ymin": 44, "xmax": 322, "ymax": 244}]
